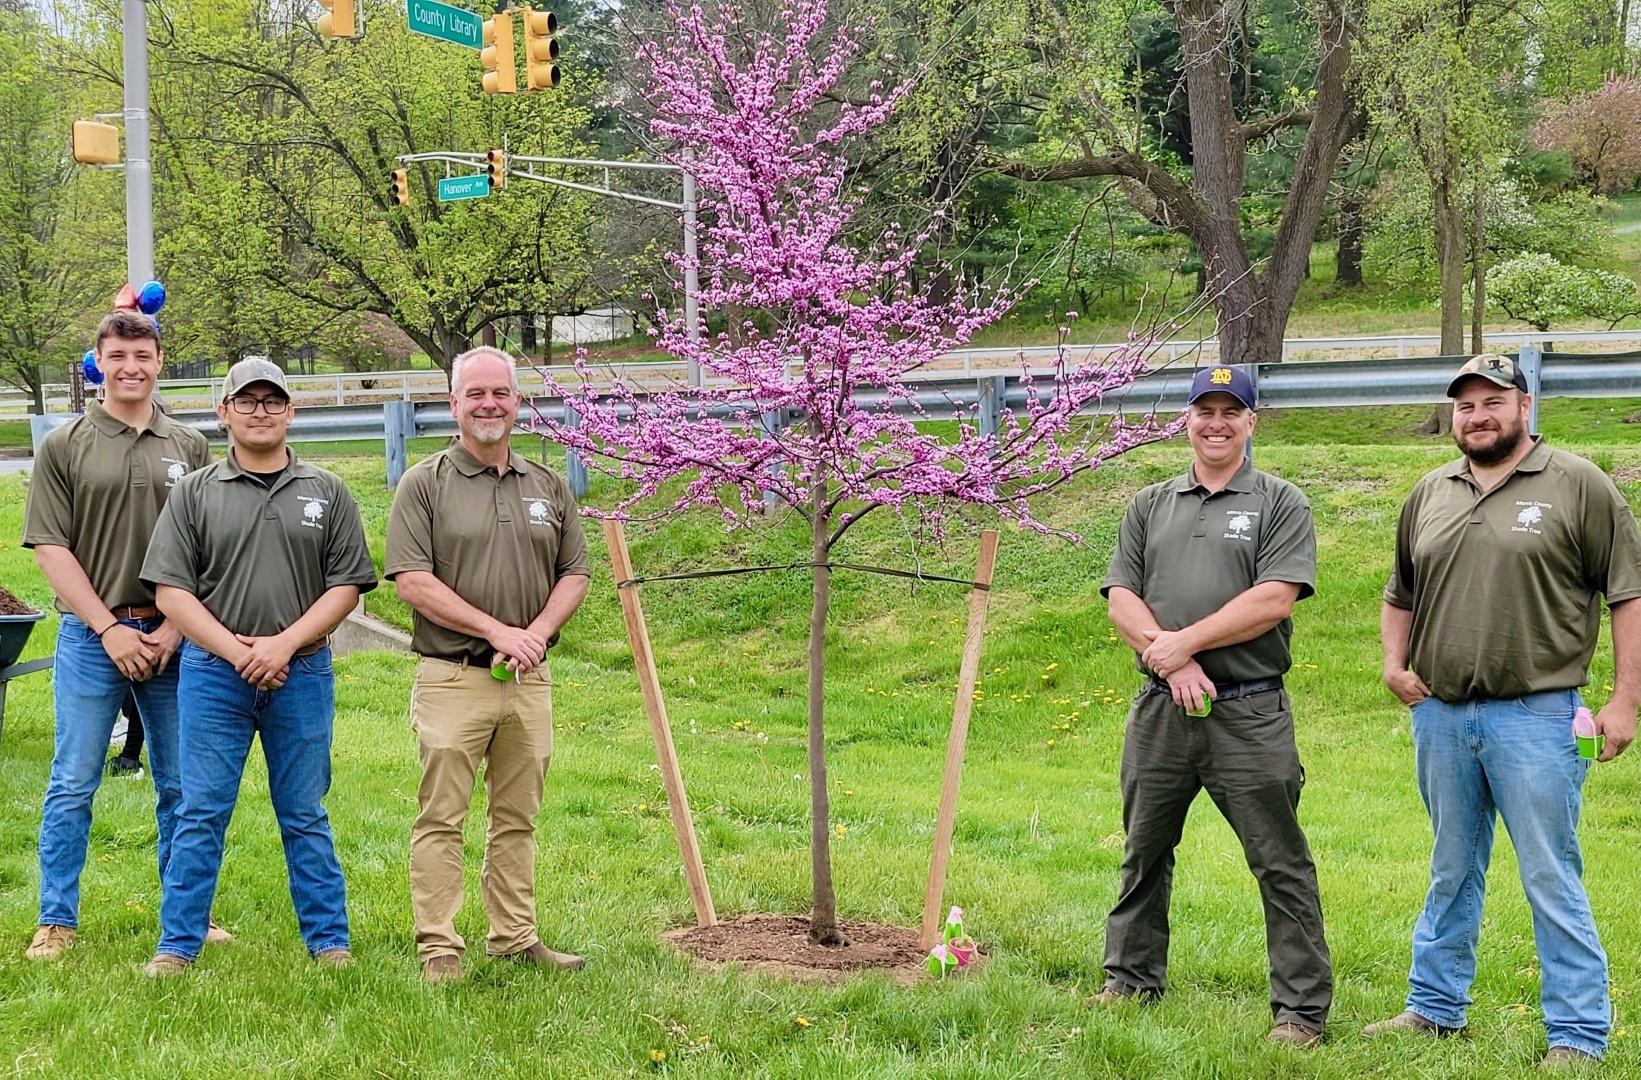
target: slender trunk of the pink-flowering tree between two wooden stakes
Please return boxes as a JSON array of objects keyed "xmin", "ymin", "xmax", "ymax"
[{"xmin": 809, "ymin": 453, "xmax": 848, "ymax": 945}]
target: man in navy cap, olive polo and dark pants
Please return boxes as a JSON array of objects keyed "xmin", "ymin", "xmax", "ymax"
[{"xmin": 1095, "ymin": 368, "xmax": 1332, "ymax": 1047}]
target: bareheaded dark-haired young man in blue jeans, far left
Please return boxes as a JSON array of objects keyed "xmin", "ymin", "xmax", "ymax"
[{"xmin": 23, "ymin": 310, "xmax": 210, "ymax": 960}]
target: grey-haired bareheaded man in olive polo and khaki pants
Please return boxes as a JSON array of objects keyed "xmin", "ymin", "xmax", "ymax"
[{"xmin": 384, "ymin": 348, "xmax": 591, "ymax": 983}]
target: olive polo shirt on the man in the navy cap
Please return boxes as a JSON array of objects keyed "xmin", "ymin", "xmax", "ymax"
[{"xmin": 1099, "ymin": 461, "xmax": 1316, "ymax": 684}]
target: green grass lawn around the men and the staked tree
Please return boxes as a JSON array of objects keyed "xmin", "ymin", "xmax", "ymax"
[{"xmin": 0, "ymin": 430, "xmax": 1641, "ymax": 1080}]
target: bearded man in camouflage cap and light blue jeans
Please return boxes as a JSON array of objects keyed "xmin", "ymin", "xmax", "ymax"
[{"xmin": 1365, "ymin": 355, "xmax": 1641, "ymax": 1067}]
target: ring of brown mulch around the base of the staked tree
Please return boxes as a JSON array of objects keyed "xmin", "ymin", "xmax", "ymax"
[{"xmin": 661, "ymin": 914, "xmax": 951, "ymax": 986}]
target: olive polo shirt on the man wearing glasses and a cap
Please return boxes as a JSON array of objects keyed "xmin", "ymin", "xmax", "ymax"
[{"xmin": 143, "ymin": 451, "xmax": 376, "ymax": 637}]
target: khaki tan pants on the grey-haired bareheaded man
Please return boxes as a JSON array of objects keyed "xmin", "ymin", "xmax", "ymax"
[{"xmin": 410, "ymin": 657, "xmax": 553, "ymax": 962}]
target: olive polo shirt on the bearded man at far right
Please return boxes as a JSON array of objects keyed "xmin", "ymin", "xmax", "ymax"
[{"xmin": 1385, "ymin": 438, "xmax": 1641, "ymax": 701}]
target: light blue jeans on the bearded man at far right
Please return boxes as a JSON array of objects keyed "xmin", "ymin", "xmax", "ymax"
[{"xmin": 1408, "ymin": 689, "xmax": 1611, "ymax": 1057}]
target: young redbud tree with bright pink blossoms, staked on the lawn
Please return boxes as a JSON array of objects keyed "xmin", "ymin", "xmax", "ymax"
[{"xmin": 533, "ymin": 0, "xmax": 1175, "ymax": 945}]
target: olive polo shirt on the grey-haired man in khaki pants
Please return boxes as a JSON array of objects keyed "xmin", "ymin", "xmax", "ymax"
[{"xmin": 384, "ymin": 443, "xmax": 592, "ymax": 663}]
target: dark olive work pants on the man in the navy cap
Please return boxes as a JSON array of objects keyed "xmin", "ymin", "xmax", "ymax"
[{"xmin": 1104, "ymin": 686, "xmax": 1332, "ymax": 1031}]
